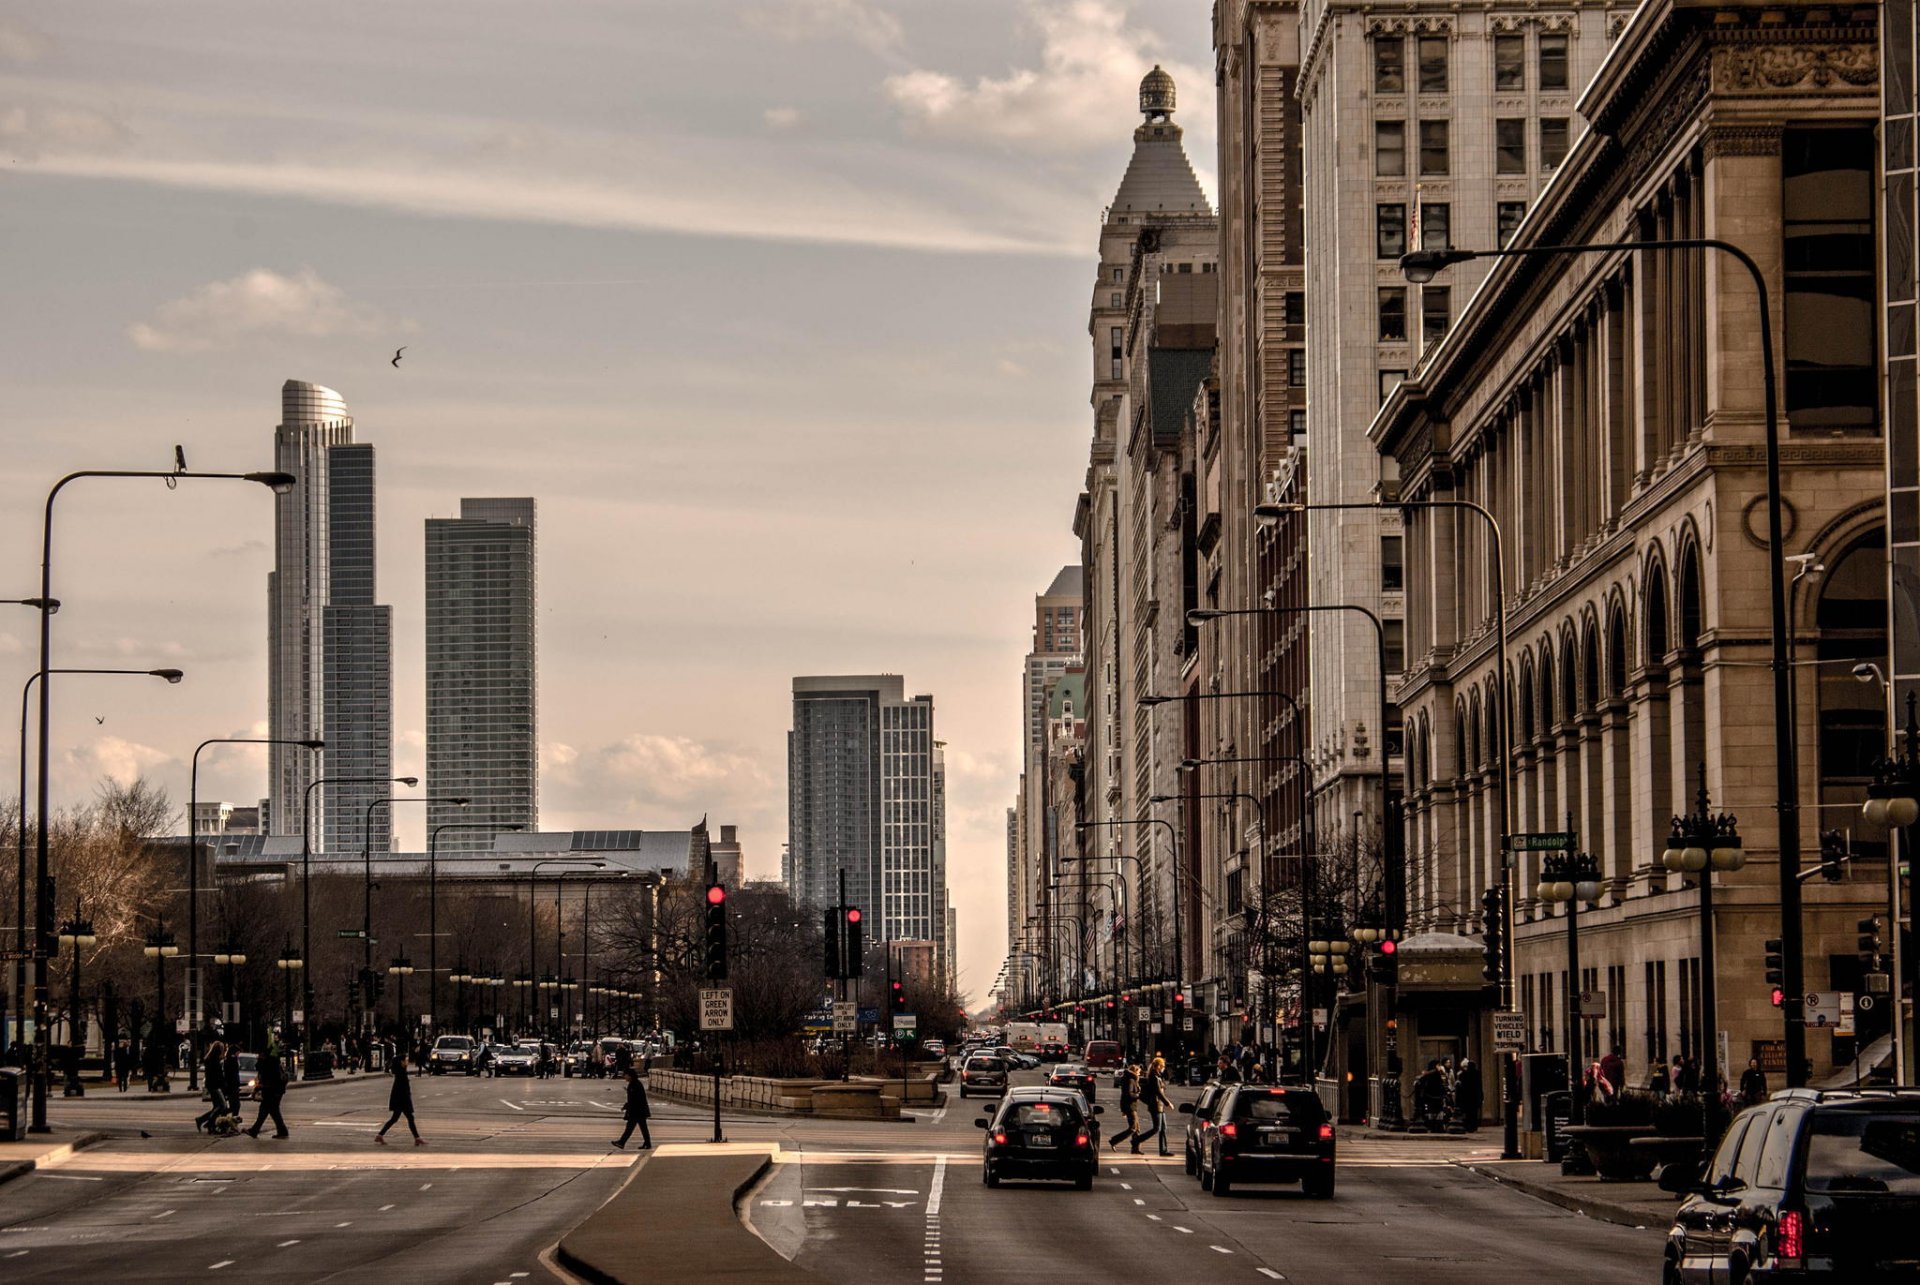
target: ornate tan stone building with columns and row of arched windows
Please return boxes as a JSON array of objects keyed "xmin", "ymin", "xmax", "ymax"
[{"xmin": 1371, "ymin": 0, "xmax": 1885, "ymax": 1085}]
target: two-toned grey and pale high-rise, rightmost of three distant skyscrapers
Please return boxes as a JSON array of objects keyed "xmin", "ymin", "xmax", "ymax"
[{"xmin": 781, "ymin": 674, "xmax": 947, "ymax": 941}]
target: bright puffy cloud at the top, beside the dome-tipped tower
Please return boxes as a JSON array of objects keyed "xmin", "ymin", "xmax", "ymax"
[{"xmin": 881, "ymin": 0, "xmax": 1210, "ymax": 152}]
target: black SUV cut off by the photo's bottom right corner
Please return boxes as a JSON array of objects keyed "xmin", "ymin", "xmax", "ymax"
[{"xmin": 1661, "ymin": 1089, "xmax": 1920, "ymax": 1285}]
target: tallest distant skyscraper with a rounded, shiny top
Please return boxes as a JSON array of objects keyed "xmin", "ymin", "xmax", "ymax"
[{"xmin": 267, "ymin": 378, "xmax": 392, "ymax": 851}]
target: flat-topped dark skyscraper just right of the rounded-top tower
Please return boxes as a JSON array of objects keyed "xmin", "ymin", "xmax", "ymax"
[{"xmin": 426, "ymin": 499, "xmax": 540, "ymax": 853}]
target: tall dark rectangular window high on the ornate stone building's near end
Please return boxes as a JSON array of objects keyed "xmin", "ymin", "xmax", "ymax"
[{"xmin": 1780, "ymin": 129, "xmax": 1880, "ymax": 428}]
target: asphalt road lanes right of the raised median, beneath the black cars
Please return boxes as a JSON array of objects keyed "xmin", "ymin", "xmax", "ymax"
[{"xmin": 747, "ymin": 1072, "xmax": 1665, "ymax": 1285}]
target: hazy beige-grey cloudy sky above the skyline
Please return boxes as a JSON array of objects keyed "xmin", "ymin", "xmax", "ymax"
[{"xmin": 0, "ymin": 0, "xmax": 1215, "ymax": 1001}]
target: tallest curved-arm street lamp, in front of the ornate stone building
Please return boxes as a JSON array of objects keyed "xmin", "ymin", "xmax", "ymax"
[{"xmin": 1400, "ymin": 236, "xmax": 1807, "ymax": 1089}]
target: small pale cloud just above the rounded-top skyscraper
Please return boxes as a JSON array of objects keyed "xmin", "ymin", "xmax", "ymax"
[{"xmin": 127, "ymin": 267, "xmax": 411, "ymax": 352}]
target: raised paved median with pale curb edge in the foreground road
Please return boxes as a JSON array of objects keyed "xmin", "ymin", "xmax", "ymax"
[{"xmin": 555, "ymin": 1143, "xmax": 822, "ymax": 1285}]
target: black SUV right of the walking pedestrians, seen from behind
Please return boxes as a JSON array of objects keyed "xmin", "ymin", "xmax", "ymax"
[{"xmin": 1200, "ymin": 1083, "xmax": 1334, "ymax": 1200}]
